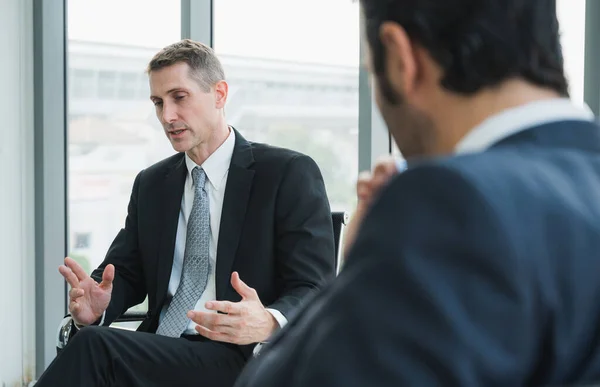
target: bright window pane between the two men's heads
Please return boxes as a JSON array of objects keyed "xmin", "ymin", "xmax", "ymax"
[{"xmin": 214, "ymin": 0, "xmax": 360, "ymax": 211}]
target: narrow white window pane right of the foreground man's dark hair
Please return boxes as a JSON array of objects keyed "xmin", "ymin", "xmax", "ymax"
[{"xmin": 556, "ymin": 0, "xmax": 585, "ymax": 104}]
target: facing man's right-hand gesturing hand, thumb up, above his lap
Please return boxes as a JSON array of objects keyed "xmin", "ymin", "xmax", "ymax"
[{"xmin": 188, "ymin": 272, "xmax": 278, "ymax": 345}]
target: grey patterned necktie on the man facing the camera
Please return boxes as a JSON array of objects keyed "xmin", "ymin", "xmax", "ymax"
[{"xmin": 156, "ymin": 167, "xmax": 210, "ymax": 337}]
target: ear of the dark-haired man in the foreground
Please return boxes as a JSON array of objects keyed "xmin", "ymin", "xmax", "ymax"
[{"xmin": 379, "ymin": 21, "xmax": 419, "ymax": 96}]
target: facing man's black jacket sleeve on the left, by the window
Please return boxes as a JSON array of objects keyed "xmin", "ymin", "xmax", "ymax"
[{"xmin": 92, "ymin": 171, "xmax": 146, "ymax": 325}]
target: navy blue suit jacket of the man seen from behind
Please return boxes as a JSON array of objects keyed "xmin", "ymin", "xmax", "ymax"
[{"xmin": 236, "ymin": 121, "xmax": 600, "ymax": 387}]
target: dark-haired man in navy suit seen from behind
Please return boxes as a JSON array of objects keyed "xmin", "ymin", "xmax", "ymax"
[{"xmin": 236, "ymin": 0, "xmax": 600, "ymax": 387}]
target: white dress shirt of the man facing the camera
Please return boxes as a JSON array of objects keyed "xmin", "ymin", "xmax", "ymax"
[{"xmin": 159, "ymin": 130, "xmax": 287, "ymax": 334}]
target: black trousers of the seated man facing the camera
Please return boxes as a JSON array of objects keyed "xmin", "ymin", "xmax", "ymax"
[{"xmin": 36, "ymin": 326, "xmax": 246, "ymax": 387}]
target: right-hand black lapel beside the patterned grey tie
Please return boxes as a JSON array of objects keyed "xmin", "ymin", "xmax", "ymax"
[{"xmin": 215, "ymin": 129, "xmax": 254, "ymax": 300}]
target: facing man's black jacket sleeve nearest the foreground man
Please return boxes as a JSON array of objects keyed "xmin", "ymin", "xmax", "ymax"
[{"xmin": 268, "ymin": 155, "xmax": 335, "ymax": 320}]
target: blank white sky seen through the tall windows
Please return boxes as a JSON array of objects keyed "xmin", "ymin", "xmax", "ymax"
[{"xmin": 67, "ymin": 0, "xmax": 586, "ymax": 102}]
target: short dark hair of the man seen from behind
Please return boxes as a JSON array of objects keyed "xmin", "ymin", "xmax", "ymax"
[{"xmin": 361, "ymin": 0, "xmax": 569, "ymax": 96}]
